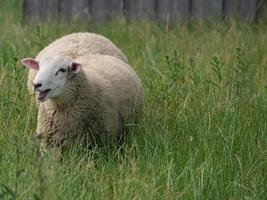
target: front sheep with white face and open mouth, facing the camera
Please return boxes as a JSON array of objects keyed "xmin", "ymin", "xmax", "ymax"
[{"xmin": 22, "ymin": 54, "xmax": 144, "ymax": 154}]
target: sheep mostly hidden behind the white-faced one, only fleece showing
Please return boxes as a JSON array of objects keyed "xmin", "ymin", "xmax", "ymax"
[{"xmin": 27, "ymin": 32, "xmax": 128, "ymax": 94}]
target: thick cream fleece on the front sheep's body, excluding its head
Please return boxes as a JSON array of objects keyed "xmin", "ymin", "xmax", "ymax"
[{"xmin": 37, "ymin": 55, "xmax": 144, "ymax": 150}]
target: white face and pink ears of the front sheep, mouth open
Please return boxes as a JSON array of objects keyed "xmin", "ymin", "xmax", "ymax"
[{"xmin": 21, "ymin": 56, "xmax": 81, "ymax": 102}]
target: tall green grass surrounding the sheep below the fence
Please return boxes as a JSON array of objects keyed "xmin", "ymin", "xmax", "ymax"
[{"xmin": 0, "ymin": 0, "xmax": 267, "ymax": 200}]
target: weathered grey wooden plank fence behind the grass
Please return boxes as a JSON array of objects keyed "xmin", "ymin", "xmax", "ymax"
[{"xmin": 23, "ymin": 0, "xmax": 267, "ymax": 23}]
